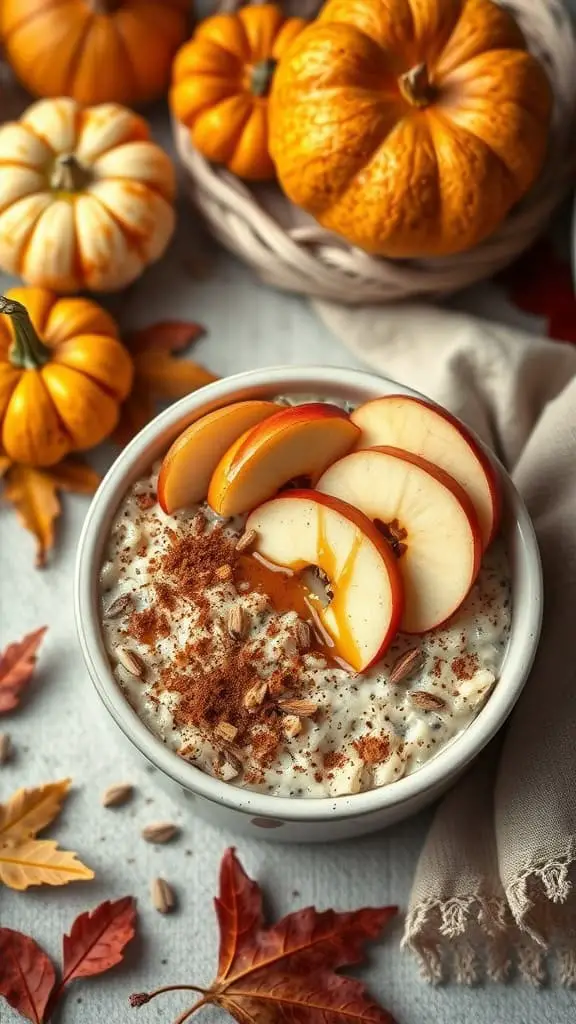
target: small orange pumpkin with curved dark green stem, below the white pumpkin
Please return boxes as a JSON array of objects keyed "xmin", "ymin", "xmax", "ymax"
[{"xmin": 0, "ymin": 288, "xmax": 133, "ymax": 466}]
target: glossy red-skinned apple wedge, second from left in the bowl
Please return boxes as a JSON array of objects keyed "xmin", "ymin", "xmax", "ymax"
[{"xmin": 208, "ymin": 401, "xmax": 360, "ymax": 516}]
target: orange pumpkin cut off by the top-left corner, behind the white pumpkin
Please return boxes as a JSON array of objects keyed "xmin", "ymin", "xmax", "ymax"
[{"xmin": 0, "ymin": 0, "xmax": 190, "ymax": 105}]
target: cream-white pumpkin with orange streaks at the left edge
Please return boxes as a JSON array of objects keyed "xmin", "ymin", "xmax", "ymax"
[{"xmin": 0, "ymin": 97, "xmax": 175, "ymax": 293}]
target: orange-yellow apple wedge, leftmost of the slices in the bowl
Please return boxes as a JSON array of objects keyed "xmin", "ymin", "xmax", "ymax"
[{"xmin": 158, "ymin": 401, "xmax": 279, "ymax": 515}]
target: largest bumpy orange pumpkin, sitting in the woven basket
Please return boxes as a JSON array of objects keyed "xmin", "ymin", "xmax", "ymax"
[{"xmin": 271, "ymin": 0, "xmax": 551, "ymax": 257}]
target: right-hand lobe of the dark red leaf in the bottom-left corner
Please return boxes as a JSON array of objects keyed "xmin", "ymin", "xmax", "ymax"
[{"xmin": 61, "ymin": 896, "xmax": 136, "ymax": 986}]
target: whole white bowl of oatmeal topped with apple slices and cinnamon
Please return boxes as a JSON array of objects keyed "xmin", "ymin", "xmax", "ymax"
[{"xmin": 75, "ymin": 367, "xmax": 542, "ymax": 842}]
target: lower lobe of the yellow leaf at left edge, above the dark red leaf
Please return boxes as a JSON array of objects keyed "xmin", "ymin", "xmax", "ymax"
[{"xmin": 0, "ymin": 839, "xmax": 94, "ymax": 890}]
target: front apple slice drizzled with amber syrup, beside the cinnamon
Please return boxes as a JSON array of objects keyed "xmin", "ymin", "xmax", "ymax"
[{"xmin": 246, "ymin": 490, "xmax": 404, "ymax": 672}]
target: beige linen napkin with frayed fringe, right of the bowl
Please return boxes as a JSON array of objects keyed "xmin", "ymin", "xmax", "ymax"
[{"xmin": 317, "ymin": 303, "xmax": 576, "ymax": 985}]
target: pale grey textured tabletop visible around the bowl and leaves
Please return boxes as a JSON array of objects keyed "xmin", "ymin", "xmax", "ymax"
[{"xmin": 0, "ymin": 105, "xmax": 576, "ymax": 1024}]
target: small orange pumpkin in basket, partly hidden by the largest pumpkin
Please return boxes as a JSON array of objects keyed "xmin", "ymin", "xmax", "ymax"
[{"xmin": 170, "ymin": 4, "xmax": 306, "ymax": 181}]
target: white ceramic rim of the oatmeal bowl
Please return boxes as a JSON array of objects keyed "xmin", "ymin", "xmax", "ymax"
[{"xmin": 74, "ymin": 366, "xmax": 543, "ymax": 822}]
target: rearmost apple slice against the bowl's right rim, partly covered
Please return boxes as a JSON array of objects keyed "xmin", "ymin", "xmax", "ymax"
[{"xmin": 351, "ymin": 394, "xmax": 500, "ymax": 549}]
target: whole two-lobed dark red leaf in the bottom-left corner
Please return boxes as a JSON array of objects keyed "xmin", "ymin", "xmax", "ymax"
[{"xmin": 0, "ymin": 896, "xmax": 135, "ymax": 1024}]
